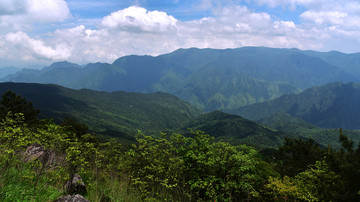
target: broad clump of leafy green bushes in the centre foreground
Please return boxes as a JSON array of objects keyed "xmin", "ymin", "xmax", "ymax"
[{"xmin": 127, "ymin": 131, "xmax": 259, "ymax": 200}]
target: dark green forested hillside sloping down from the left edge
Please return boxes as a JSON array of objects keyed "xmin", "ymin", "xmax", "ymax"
[{"xmin": 0, "ymin": 83, "xmax": 202, "ymax": 139}]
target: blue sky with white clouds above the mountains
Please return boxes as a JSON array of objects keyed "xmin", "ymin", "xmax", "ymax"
[{"xmin": 0, "ymin": 0, "xmax": 360, "ymax": 67}]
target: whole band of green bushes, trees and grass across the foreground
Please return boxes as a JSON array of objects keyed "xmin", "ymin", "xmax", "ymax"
[{"xmin": 0, "ymin": 92, "xmax": 360, "ymax": 201}]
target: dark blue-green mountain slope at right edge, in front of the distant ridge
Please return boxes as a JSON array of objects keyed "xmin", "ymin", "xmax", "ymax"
[{"xmin": 232, "ymin": 83, "xmax": 360, "ymax": 129}]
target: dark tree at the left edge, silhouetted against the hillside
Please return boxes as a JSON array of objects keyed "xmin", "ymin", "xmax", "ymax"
[{"xmin": 0, "ymin": 90, "xmax": 39, "ymax": 124}]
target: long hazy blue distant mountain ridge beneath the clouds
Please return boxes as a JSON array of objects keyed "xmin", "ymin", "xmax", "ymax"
[{"xmin": 3, "ymin": 47, "xmax": 360, "ymax": 111}]
